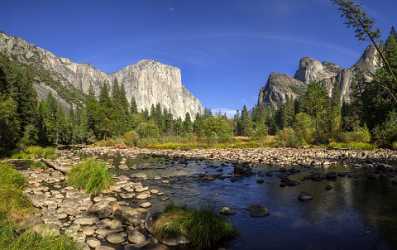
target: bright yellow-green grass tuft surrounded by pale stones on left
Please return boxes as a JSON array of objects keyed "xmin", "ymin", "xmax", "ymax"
[{"xmin": 68, "ymin": 159, "xmax": 112, "ymax": 194}]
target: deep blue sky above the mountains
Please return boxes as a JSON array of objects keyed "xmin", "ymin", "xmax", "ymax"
[{"xmin": 0, "ymin": 0, "xmax": 397, "ymax": 109}]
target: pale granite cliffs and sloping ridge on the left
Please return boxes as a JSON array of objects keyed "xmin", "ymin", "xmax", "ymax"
[{"xmin": 0, "ymin": 32, "xmax": 204, "ymax": 118}]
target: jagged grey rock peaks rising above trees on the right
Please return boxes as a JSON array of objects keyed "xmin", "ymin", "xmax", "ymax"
[{"xmin": 258, "ymin": 46, "xmax": 380, "ymax": 108}]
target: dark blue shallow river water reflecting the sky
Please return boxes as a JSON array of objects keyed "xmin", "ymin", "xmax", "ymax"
[{"xmin": 100, "ymin": 152, "xmax": 397, "ymax": 250}]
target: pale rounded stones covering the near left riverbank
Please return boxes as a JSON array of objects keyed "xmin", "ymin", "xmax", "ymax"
[{"xmin": 22, "ymin": 151, "xmax": 167, "ymax": 250}]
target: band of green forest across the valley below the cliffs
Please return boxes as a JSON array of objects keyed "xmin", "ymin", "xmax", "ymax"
[{"xmin": 0, "ymin": 20, "xmax": 397, "ymax": 153}]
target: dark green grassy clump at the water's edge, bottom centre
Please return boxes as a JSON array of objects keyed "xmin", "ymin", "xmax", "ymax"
[{"xmin": 154, "ymin": 206, "xmax": 237, "ymax": 249}]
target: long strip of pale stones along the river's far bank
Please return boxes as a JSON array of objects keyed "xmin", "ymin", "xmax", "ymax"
[{"xmin": 82, "ymin": 147, "xmax": 397, "ymax": 167}]
